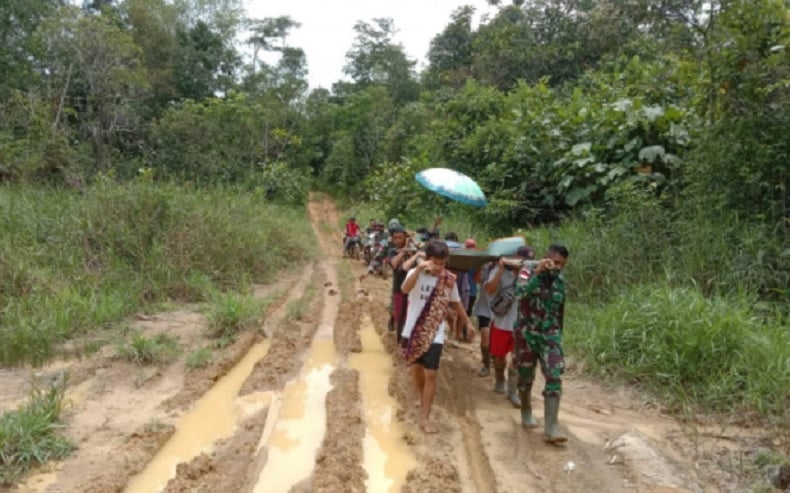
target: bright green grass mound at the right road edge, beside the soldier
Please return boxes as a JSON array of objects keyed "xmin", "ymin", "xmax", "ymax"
[{"xmin": 565, "ymin": 285, "xmax": 790, "ymax": 418}]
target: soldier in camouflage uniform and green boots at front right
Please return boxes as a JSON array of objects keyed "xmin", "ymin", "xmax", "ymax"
[{"xmin": 514, "ymin": 244, "xmax": 568, "ymax": 444}]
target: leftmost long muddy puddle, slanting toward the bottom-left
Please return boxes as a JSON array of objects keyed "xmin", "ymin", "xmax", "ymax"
[{"xmin": 125, "ymin": 340, "xmax": 269, "ymax": 493}]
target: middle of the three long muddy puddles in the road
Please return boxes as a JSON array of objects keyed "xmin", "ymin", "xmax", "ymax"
[{"xmin": 253, "ymin": 338, "xmax": 337, "ymax": 493}]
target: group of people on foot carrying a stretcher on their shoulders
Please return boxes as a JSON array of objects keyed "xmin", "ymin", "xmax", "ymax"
[{"xmin": 350, "ymin": 215, "xmax": 569, "ymax": 444}]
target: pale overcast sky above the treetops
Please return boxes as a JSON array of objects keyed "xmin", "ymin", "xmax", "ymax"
[{"xmin": 246, "ymin": 0, "xmax": 491, "ymax": 89}]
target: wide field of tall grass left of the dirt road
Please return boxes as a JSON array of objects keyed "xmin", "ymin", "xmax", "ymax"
[{"xmin": 0, "ymin": 182, "xmax": 315, "ymax": 365}]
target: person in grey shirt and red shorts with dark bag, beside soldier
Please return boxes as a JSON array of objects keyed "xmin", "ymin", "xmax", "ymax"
[{"xmin": 485, "ymin": 245, "xmax": 535, "ymax": 407}]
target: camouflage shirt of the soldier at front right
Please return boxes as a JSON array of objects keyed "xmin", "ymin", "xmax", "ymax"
[{"xmin": 516, "ymin": 267, "xmax": 565, "ymax": 332}]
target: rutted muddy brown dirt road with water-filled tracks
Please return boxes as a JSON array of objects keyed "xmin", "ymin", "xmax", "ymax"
[{"xmin": 0, "ymin": 196, "xmax": 768, "ymax": 493}]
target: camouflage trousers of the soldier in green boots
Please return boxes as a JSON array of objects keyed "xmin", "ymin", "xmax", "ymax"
[{"xmin": 513, "ymin": 328, "xmax": 565, "ymax": 396}]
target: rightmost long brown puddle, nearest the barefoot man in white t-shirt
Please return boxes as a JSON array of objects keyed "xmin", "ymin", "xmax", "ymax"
[{"xmin": 349, "ymin": 314, "xmax": 417, "ymax": 492}]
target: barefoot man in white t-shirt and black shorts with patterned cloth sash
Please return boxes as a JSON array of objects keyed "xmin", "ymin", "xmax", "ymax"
[{"xmin": 401, "ymin": 240, "xmax": 475, "ymax": 433}]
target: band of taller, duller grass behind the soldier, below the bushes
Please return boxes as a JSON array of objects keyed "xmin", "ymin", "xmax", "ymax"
[{"xmin": 522, "ymin": 202, "xmax": 790, "ymax": 306}]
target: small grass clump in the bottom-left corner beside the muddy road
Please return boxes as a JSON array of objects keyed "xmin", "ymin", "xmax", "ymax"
[{"xmin": 0, "ymin": 378, "xmax": 73, "ymax": 486}]
